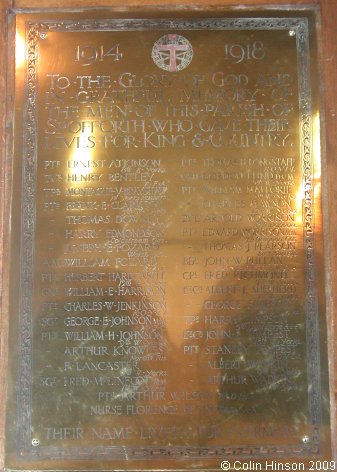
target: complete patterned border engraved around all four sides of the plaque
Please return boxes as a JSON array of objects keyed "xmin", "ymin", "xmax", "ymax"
[{"xmin": 17, "ymin": 18, "xmax": 322, "ymax": 460}]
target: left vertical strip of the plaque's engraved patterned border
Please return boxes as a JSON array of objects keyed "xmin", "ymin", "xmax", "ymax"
[{"xmin": 17, "ymin": 21, "xmax": 39, "ymax": 452}]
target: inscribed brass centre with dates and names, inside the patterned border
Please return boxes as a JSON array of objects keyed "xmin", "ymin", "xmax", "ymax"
[{"xmin": 26, "ymin": 26, "xmax": 307, "ymax": 446}]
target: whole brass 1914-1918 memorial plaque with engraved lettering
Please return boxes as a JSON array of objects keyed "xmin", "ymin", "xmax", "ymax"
[{"xmin": 6, "ymin": 9, "xmax": 331, "ymax": 470}]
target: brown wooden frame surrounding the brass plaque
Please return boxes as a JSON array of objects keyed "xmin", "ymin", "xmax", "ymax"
[{"xmin": 0, "ymin": 0, "xmax": 337, "ymax": 469}]
